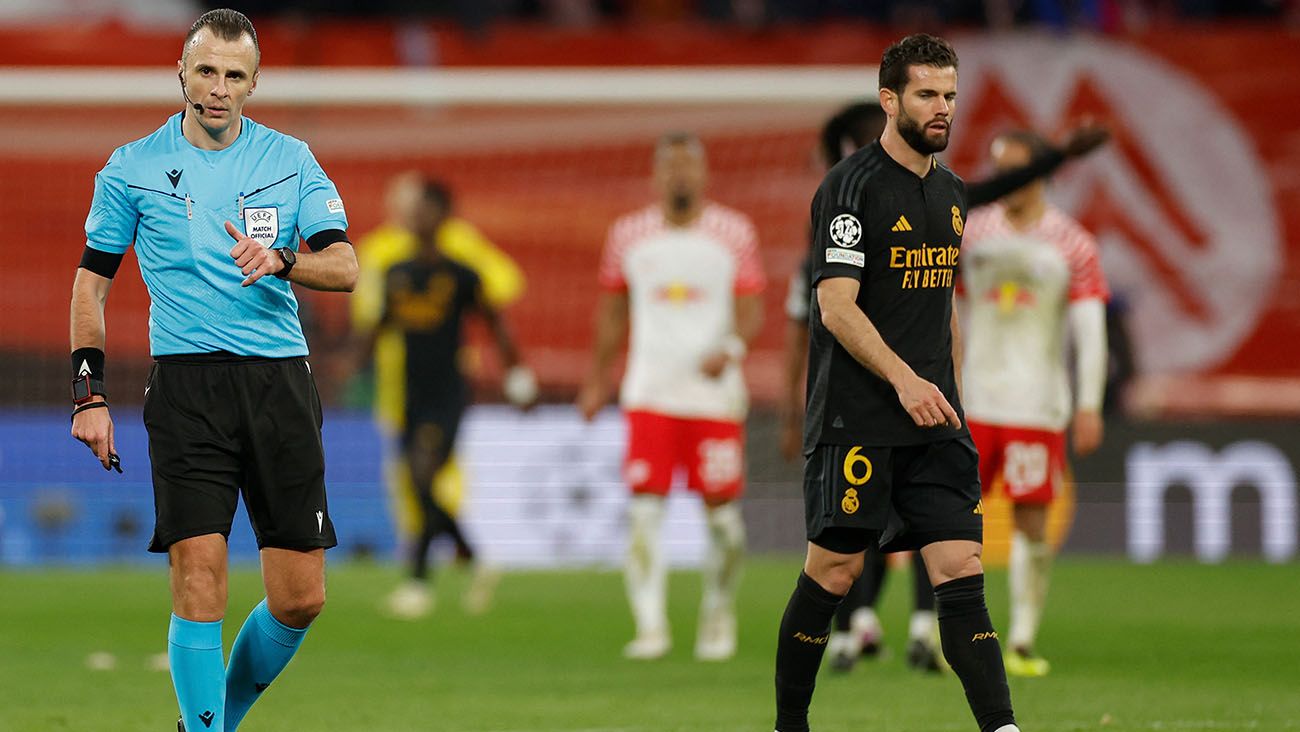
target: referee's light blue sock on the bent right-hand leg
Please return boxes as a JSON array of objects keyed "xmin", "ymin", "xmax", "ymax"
[{"xmin": 223, "ymin": 599, "xmax": 307, "ymax": 732}]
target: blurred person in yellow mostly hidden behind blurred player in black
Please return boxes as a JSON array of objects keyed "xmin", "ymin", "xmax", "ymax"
[{"xmin": 351, "ymin": 170, "xmax": 525, "ymax": 608}]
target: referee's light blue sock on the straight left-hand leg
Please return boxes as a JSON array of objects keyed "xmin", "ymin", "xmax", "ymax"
[{"xmin": 166, "ymin": 615, "xmax": 226, "ymax": 732}]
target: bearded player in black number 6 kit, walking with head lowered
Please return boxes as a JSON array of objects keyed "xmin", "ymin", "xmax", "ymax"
[{"xmin": 776, "ymin": 34, "xmax": 1019, "ymax": 732}]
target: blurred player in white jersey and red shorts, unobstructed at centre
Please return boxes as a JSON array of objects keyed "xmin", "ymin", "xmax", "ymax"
[{"xmin": 579, "ymin": 133, "xmax": 766, "ymax": 660}]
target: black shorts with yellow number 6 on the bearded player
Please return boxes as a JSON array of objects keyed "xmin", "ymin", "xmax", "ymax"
[{"xmin": 803, "ymin": 436, "xmax": 984, "ymax": 554}]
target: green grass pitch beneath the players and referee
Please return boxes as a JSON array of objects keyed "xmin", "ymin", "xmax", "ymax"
[{"xmin": 0, "ymin": 556, "xmax": 1300, "ymax": 732}]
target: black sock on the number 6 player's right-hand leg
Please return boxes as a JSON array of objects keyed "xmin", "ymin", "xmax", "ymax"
[{"xmin": 935, "ymin": 575, "xmax": 1015, "ymax": 732}]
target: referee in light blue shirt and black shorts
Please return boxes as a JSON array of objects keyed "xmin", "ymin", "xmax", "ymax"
[{"xmin": 72, "ymin": 9, "xmax": 356, "ymax": 732}]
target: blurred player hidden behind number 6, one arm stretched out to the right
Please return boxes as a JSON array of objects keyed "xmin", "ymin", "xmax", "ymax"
[{"xmin": 781, "ymin": 101, "xmax": 1109, "ymax": 671}]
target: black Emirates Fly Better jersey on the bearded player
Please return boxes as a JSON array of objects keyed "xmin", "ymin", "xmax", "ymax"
[{"xmin": 803, "ymin": 142, "xmax": 967, "ymax": 452}]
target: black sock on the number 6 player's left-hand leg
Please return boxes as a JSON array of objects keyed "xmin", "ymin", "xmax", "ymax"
[{"xmin": 776, "ymin": 572, "xmax": 842, "ymax": 732}]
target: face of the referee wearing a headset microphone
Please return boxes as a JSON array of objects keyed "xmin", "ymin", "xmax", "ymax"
[{"xmin": 179, "ymin": 29, "xmax": 257, "ymax": 135}]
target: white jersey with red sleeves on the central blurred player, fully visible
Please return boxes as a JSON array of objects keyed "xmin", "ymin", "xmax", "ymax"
[{"xmin": 599, "ymin": 203, "xmax": 766, "ymax": 421}]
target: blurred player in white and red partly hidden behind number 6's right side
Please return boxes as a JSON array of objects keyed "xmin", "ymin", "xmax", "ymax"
[{"xmin": 962, "ymin": 131, "xmax": 1109, "ymax": 676}]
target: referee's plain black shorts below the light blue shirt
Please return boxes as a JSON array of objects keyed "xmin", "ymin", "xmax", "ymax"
[{"xmin": 144, "ymin": 354, "xmax": 338, "ymax": 553}]
